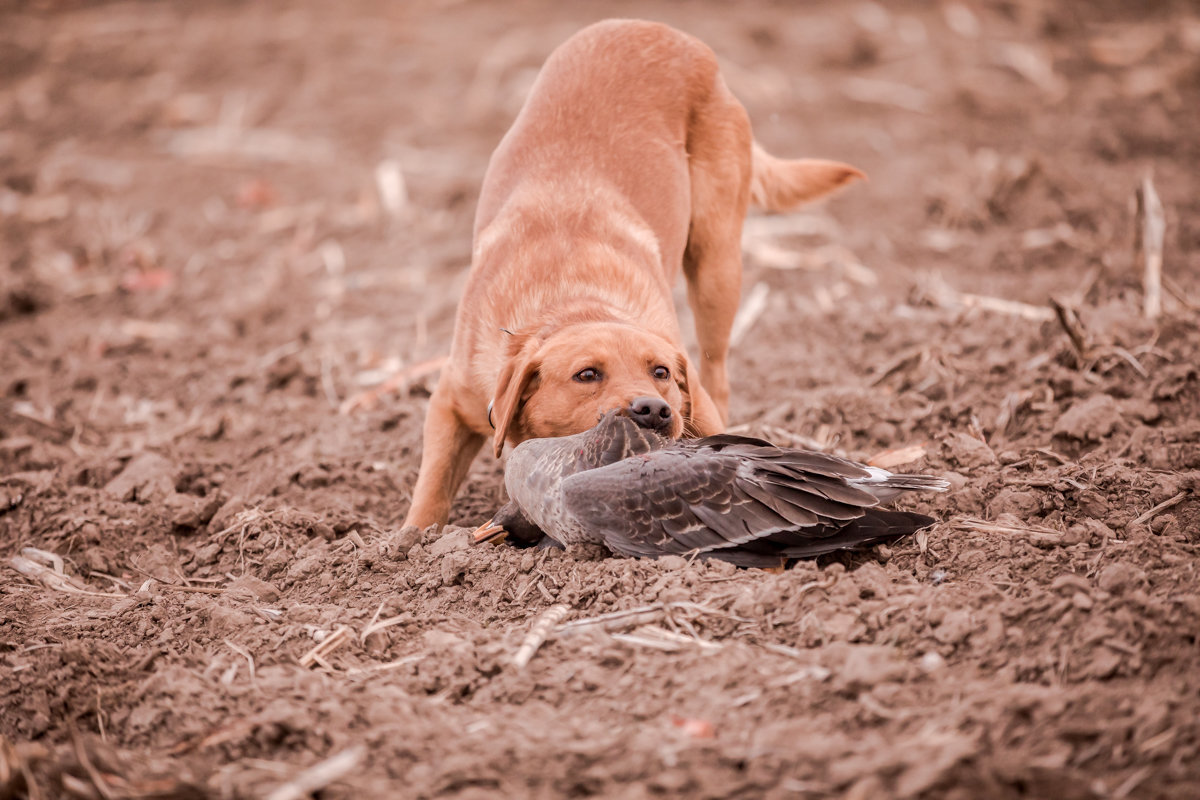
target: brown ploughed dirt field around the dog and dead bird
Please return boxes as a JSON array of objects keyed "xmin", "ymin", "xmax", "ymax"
[{"xmin": 0, "ymin": 0, "xmax": 1200, "ymax": 800}]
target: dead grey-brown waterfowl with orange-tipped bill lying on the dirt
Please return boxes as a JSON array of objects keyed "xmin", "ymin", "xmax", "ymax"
[{"xmin": 475, "ymin": 410, "xmax": 949, "ymax": 567}]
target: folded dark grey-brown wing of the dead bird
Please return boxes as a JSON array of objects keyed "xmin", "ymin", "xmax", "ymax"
[{"xmin": 562, "ymin": 437, "xmax": 932, "ymax": 566}]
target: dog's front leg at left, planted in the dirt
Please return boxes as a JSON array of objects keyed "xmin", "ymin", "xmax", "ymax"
[{"xmin": 404, "ymin": 384, "xmax": 485, "ymax": 528}]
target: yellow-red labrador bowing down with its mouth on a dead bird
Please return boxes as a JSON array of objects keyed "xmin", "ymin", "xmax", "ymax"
[{"xmin": 406, "ymin": 20, "xmax": 863, "ymax": 528}]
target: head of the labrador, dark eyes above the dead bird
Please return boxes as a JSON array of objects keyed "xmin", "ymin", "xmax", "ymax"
[{"xmin": 492, "ymin": 321, "xmax": 694, "ymax": 456}]
